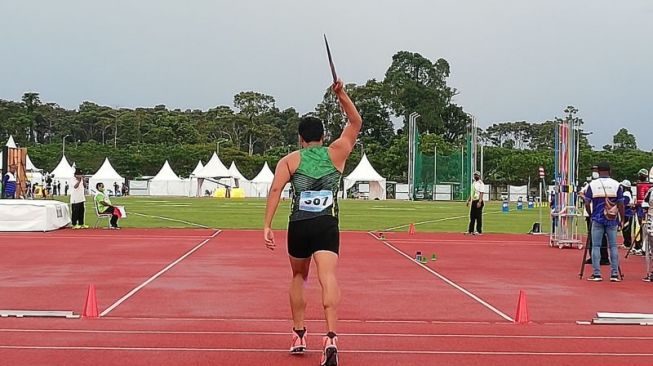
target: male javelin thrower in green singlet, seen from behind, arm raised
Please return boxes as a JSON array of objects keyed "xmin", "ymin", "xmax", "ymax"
[{"xmin": 263, "ymin": 80, "xmax": 363, "ymax": 366}]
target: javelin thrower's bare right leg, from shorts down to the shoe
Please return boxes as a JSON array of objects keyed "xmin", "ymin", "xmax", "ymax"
[{"xmin": 313, "ymin": 250, "xmax": 340, "ymax": 333}]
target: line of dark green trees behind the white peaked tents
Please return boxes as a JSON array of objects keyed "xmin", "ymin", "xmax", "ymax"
[{"xmin": 0, "ymin": 51, "xmax": 653, "ymax": 185}]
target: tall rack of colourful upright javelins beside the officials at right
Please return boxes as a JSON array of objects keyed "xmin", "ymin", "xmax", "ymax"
[{"xmin": 549, "ymin": 119, "xmax": 583, "ymax": 249}]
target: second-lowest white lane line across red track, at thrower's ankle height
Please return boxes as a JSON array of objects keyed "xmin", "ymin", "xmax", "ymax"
[{"xmin": 0, "ymin": 328, "xmax": 653, "ymax": 341}]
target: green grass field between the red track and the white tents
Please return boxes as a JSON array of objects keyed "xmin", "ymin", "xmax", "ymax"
[{"xmin": 61, "ymin": 197, "xmax": 551, "ymax": 233}]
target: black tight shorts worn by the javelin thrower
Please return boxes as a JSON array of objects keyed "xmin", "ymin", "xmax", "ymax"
[{"xmin": 288, "ymin": 215, "xmax": 340, "ymax": 259}]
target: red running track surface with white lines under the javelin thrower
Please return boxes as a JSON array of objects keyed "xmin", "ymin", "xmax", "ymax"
[{"xmin": 0, "ymin": 230, "xmax": 653, "ymax": 366}]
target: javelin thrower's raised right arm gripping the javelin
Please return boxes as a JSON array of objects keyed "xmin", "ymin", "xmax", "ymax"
[{"xmin": 329, "ymin": 80, "xmax": 363, "ymax": 172}]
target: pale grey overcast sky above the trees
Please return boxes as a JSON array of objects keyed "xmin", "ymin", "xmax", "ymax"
[{"xmin": 0, "ymin": 0, "xmax": 653, "ymax": 150}]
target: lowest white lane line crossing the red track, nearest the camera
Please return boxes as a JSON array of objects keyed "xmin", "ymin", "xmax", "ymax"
[{"xmin": 0, "ymin": 345, "xmax": 653, "ymax": 357}]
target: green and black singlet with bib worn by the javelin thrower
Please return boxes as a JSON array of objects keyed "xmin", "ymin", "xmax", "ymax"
[{"xmin": 290, "ymin": 146, "xmax": 342, "ymax": 221}]
